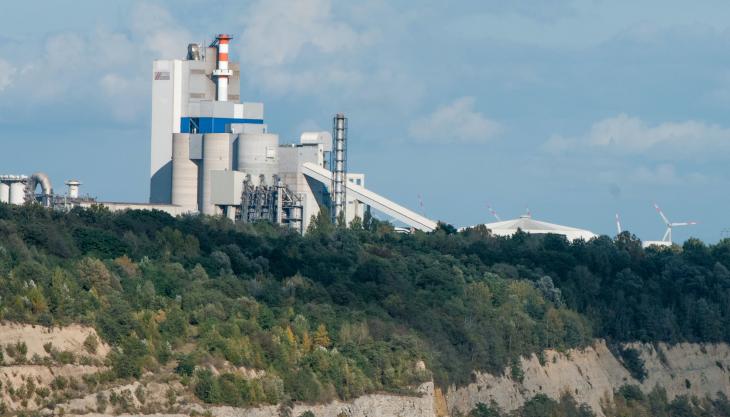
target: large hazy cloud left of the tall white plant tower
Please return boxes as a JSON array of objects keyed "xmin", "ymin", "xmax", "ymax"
[{"xmin": 0, "ymin": 2, "xmax": 188, "ymax": 123}]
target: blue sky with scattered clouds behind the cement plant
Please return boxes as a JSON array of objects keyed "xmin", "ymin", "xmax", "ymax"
[{"xmin": 0, "ymin": 0, "xmax": 730, "ymax": 242}]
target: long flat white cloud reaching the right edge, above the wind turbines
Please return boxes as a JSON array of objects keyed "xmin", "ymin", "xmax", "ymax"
[{"xmin": 543, "ymin": 114, "xmax": 730, "ymax": 158}]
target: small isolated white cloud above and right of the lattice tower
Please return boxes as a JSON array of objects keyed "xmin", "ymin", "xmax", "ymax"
[{"xmin": 408, "ymin": 97, "xmax": 502, "ymax": 143}]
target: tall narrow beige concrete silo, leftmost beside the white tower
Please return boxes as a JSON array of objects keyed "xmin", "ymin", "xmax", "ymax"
[{"xmin": 172, "ymin": 133, "xmax": 198, "ymax": 211}]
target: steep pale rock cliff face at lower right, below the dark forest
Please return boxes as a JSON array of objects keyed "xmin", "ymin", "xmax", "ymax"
[{"xmin": 445, "ymin": 341, "xmax": 730, "ymax": 415}]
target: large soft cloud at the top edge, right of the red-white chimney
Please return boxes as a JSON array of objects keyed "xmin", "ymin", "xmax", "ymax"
[{"xmin": 234, "ymin": 0, "xmax": 372, "ymax": 95}]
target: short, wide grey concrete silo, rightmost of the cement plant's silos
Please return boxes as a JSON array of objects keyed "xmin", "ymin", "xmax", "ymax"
[{"xmin": 237, "ymin": 133, "xmax": 279, "ymax": 186}]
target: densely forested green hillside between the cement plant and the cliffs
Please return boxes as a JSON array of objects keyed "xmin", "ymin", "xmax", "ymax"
[{"xmin": 0, "ymin": 204, "xmax": 730, "ymax": 412}]
